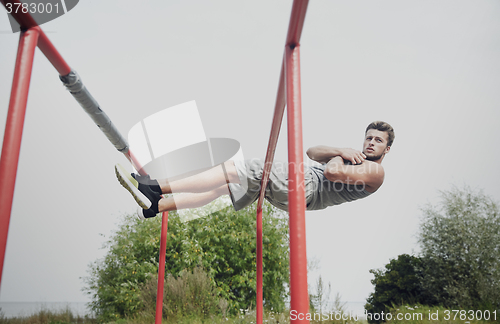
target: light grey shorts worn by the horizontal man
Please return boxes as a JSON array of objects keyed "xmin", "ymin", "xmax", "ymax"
[{"xmin": 228, "ymin": 159, "xmax": 314, "ymax": 211}]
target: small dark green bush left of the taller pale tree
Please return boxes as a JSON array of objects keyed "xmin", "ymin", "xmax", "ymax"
[{"xmin": 365, "ymin": 254, "xmax": 429, "ymax": 323}]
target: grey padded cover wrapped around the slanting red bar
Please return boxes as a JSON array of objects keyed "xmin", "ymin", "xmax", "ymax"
[{"xmin": 59, "ymin": 71, "xmax": 128, "ymax": 153}]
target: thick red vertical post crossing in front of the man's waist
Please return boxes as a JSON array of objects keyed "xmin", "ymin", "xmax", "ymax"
[{"xmin": 285, "ymin": 45, "xmax": 309, "ymax": 323}]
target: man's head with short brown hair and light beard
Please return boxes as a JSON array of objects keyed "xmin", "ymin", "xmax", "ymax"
[{"xmin": 363, "ymin": 121, "xmax": 396, "ymax": 163}]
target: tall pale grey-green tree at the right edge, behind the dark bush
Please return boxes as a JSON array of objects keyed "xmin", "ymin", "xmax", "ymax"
[{"xmin": 419, "ymin": 187, "xmax": 500, "ymax": 308}]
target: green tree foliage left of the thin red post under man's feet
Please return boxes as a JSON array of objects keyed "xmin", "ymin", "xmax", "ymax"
[{"xmin": 85, "ymin": 216, "xmax": 161, "ymax": 321}]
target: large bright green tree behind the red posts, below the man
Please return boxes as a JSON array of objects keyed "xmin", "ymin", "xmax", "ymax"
[{"xmin": 85, "ymin": 204, "xmax": 288, "ymax": 320}]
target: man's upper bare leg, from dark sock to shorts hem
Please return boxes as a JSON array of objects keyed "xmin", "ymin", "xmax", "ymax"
[{"xmin": 157, "ymin": 161, "xmax": 240, "ymax": 194}]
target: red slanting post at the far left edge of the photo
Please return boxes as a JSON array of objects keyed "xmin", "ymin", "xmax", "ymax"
[{"xmin": 0, "ymin": 28, "xmax": 39, "ymax": 284}]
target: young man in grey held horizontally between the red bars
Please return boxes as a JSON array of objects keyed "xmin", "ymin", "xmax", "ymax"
[{"xmin": 115, "ymin": 121, "xmax": 395, "ymax": 218}]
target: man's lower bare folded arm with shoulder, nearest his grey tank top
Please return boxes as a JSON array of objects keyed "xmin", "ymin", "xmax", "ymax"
[{"xmin": 324, "ymin": 156, "xmax": 384, "ymax": 192}]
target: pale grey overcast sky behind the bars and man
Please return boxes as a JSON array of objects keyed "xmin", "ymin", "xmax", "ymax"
[{"xmin": 0, "ymin": 0, "xmax": 500, "ymax": 312}]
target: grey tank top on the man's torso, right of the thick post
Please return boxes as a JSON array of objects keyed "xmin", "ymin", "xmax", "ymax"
[{"xmin": 304, "ymin": 164, "xmax": 372, "ymax": 210}]
